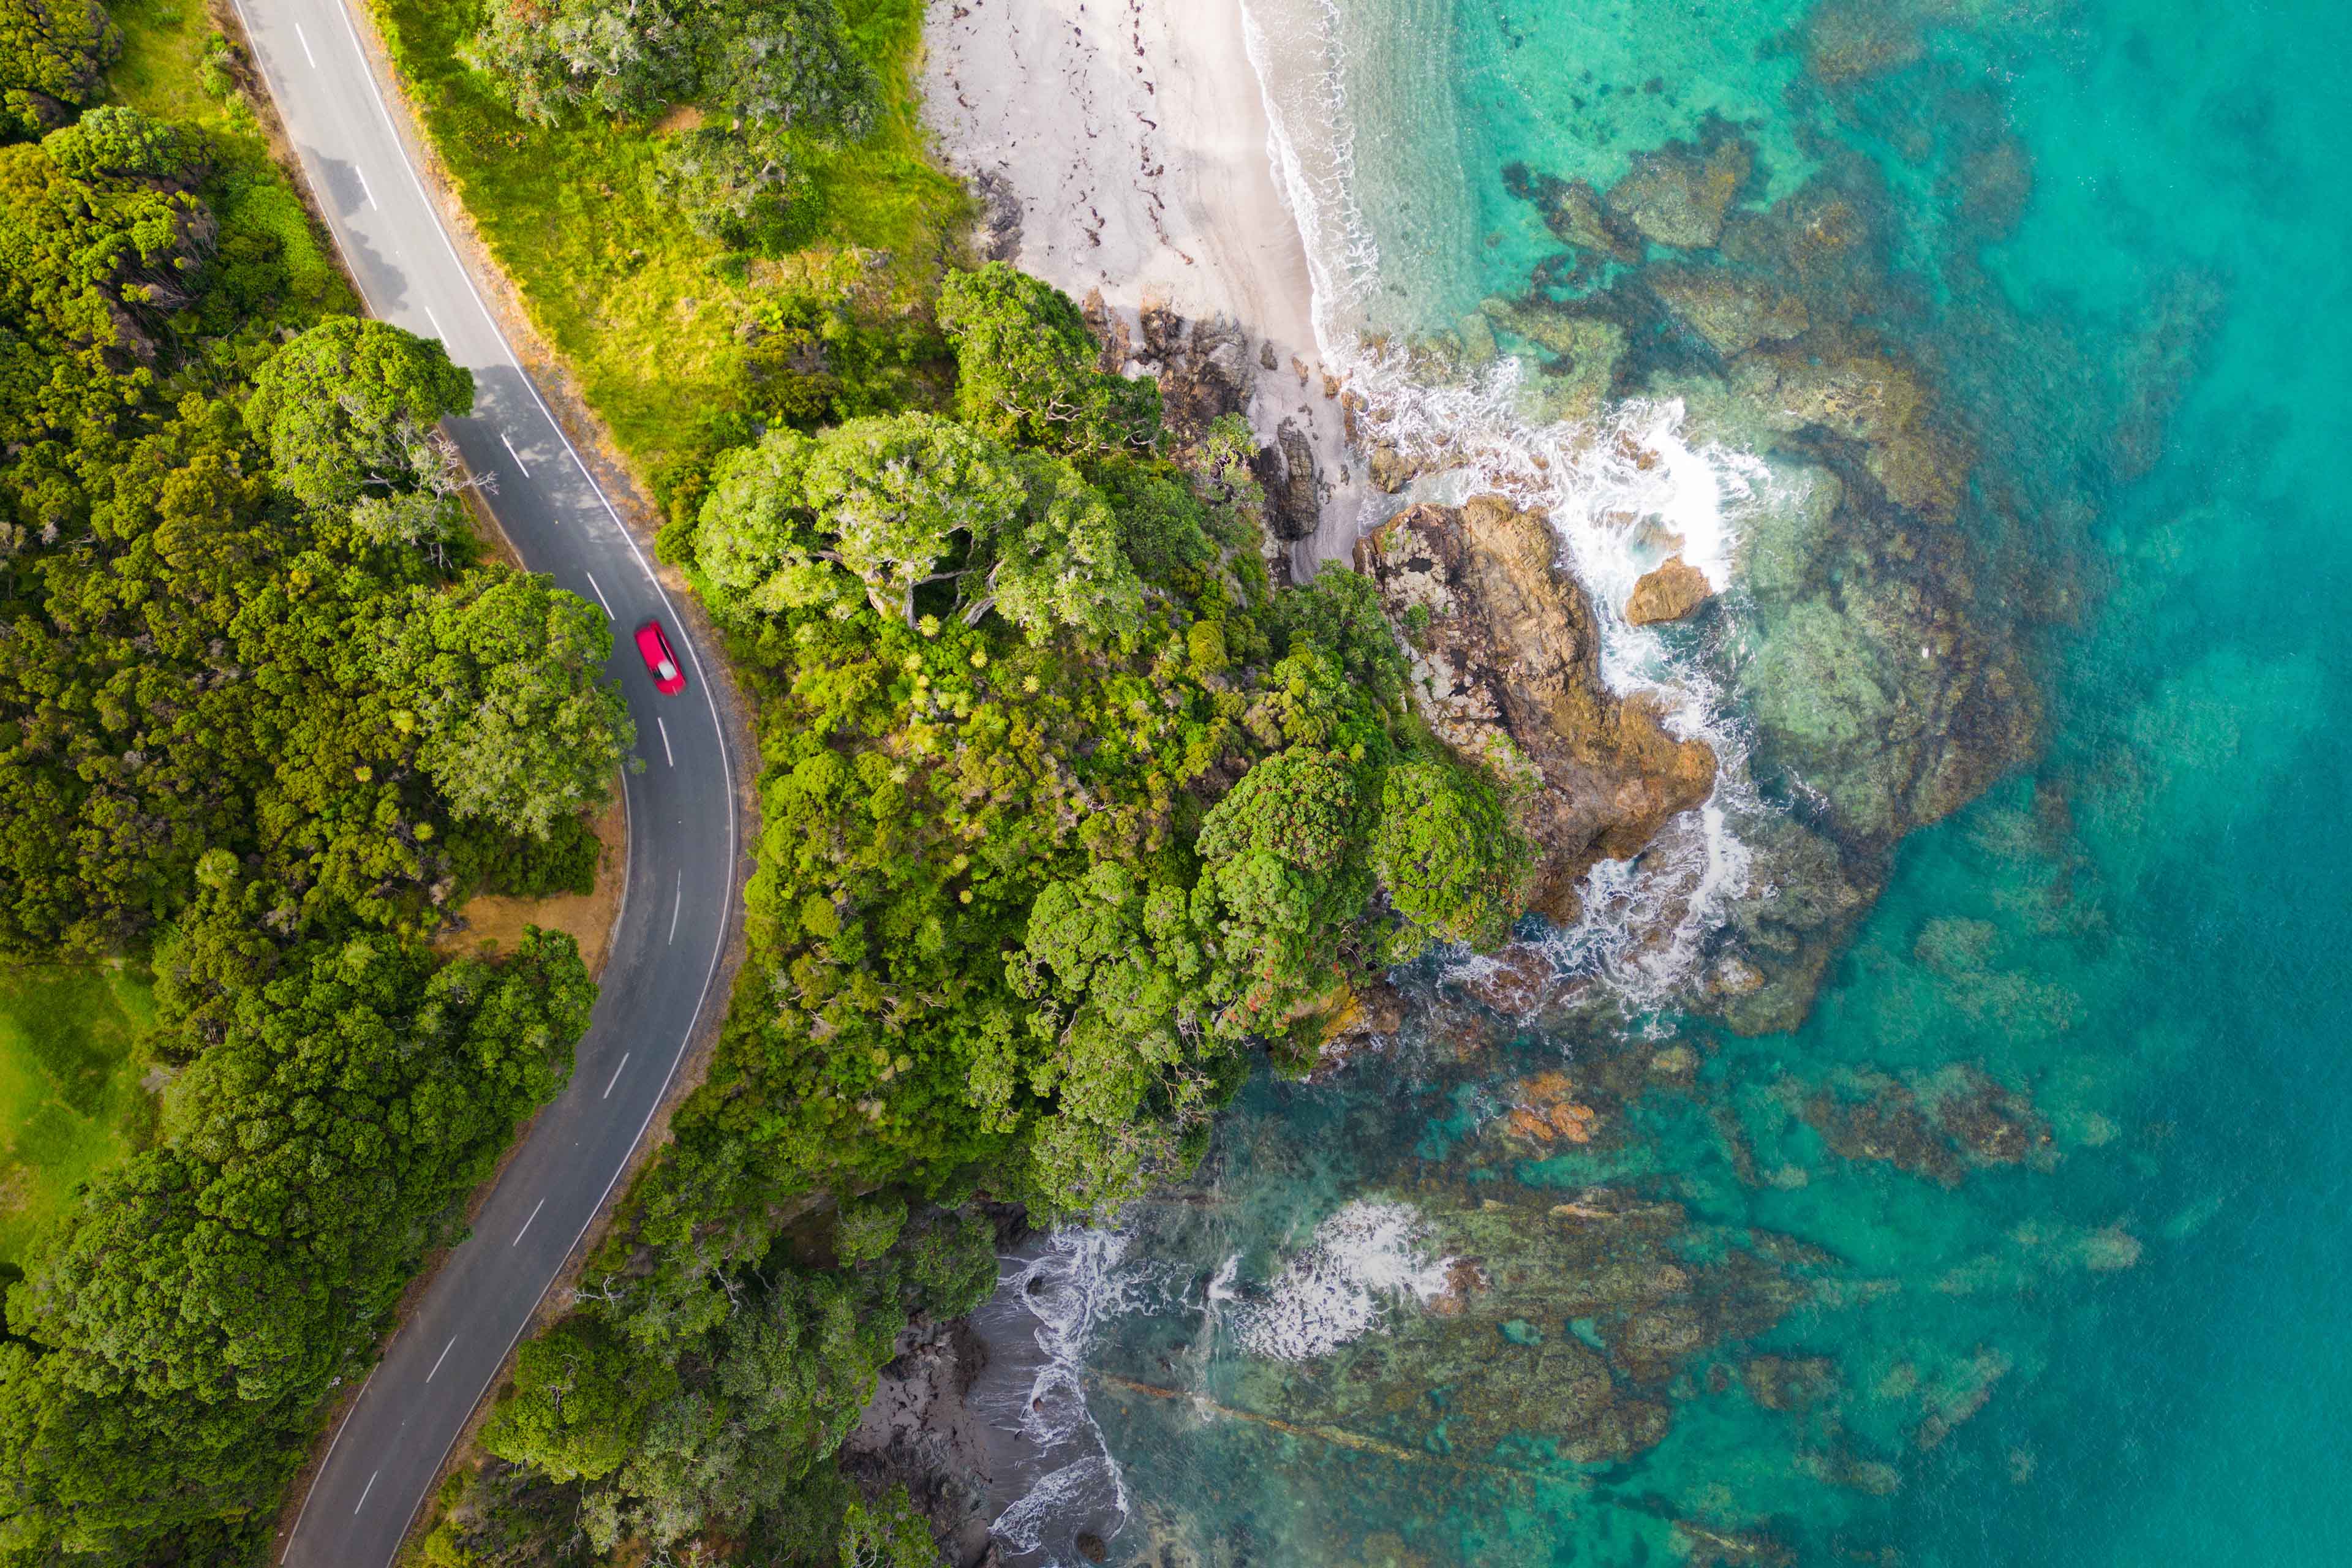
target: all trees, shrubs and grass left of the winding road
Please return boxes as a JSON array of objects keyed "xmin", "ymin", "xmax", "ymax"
[{"xmin": 0, "ymin": 0, "xmax": 630, "ymax": 1563}]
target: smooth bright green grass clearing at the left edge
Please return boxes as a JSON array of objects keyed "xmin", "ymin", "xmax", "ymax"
[{"xmin": 0, "ymin": 964, "xmax": 155, "ymax": 1262}]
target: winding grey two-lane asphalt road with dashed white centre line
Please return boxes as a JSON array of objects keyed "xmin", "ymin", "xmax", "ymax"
[{"xmin": 220, "ymin": 0, "xmax": 736, "ymax": 1568}]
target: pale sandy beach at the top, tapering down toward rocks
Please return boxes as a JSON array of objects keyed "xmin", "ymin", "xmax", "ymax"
[{"xmin": 924, "ymin": 0, "xmax": 1369, "ymax": 569}]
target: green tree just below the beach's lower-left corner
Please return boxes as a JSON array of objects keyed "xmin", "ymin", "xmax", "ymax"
[{"xmin": 938, "ymin": 261, "xmax": 1159, "ymax": 456}]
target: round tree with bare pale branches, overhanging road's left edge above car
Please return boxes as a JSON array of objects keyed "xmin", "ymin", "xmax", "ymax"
[{"xmin": 244, "ymin": 315, "xmax": 473, "ymax": 505}]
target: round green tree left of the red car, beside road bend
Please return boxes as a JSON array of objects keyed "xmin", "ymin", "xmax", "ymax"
[{"xmin": 383, "ymin": 571, "xmax": 638, "ymax": 839}]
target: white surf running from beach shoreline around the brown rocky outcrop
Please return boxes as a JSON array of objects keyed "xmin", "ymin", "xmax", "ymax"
[{"xmin": 1242, "ymin": 0, "xmax": 1776, "ymax": 1009}]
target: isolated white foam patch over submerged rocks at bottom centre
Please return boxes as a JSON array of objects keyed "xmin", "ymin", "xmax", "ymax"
[{"xmin": 1235, "ymin": 1199, "xmax": 1451, "ymax": 1361}]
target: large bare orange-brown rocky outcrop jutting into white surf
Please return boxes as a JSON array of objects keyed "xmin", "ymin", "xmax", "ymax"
[{"xmin": 1357, "ymin": 496, "xmax": 1714, "ymax": 922}]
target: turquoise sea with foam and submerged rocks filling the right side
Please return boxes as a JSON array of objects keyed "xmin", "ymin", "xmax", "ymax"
[{"xmin": 990, "ymin": 0, "xmax": 2352, "ymax": 1568}]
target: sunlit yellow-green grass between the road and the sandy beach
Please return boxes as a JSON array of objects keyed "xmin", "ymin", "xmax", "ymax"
[{"xmin": 372, "ymin": 0, "xmax": 967, "ymax": 475}]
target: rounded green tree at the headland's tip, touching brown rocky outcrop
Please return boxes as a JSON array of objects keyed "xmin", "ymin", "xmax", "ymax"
[{"xmin": 1371, "ymin": 762, "xmax": 1529, "ymax": 962}]
